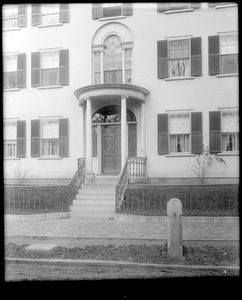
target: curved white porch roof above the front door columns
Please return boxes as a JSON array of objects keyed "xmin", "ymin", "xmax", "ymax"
[{"xmin": 74, "ymin": 84, "xmax": 149, "ymax": 104}]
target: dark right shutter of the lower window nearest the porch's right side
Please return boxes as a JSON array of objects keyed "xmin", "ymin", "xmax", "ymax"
[{"xmin": 191, "ymin": 112, "xmax": 203, "ymax": 154}]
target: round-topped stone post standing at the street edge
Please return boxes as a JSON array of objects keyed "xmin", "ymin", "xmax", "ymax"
[{"xmin": 167, "ymin": 198, "xmax": 183, "ymax": 257}]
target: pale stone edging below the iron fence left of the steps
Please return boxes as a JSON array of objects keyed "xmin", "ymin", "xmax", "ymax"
[{"xmin": 4, "ymin": 212, "xmax": 69, "ymax": 221}]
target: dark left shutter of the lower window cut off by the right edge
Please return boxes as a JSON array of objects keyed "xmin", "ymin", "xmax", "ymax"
[{"xmin": 209, "ymin": 111, "xmax": 221, "ymax": 153}]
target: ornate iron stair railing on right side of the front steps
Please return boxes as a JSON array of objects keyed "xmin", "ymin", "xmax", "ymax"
[{"xmin": 115, "ymin": 157, "xmax": 147, "ymax": 210}]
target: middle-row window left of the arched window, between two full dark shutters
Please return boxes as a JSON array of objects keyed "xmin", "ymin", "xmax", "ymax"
[{"xmin": 41, "ymin": 51, "xmax": 59, "ymax": 86}]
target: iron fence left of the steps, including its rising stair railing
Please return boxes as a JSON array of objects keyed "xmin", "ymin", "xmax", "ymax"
[{"xmin": 4, "ymin": 158, "xmax": 85, "ymax": 214}]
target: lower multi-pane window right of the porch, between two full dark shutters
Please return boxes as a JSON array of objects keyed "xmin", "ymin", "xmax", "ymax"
[{"xmin": 169, "ymin": 113, "xmax": 191, "ymax": 153}]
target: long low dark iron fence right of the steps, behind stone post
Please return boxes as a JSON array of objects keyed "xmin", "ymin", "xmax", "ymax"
[{"xmin": 116, "ymin": 184, "xmax": 239, "ymax": 216}]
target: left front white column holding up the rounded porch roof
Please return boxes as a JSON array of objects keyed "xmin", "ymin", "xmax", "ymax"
[{"xmin": 86, "ymin": 98, "xmax": 93, "ymax": 174}]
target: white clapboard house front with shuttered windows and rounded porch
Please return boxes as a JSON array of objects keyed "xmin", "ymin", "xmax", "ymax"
[{"xmin": 2, "ymin": 2, "xmax": 239, "ymax": 184}]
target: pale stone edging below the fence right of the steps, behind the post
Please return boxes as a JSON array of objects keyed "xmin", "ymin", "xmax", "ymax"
[{"xmin": 114, "ymin": 214, "xmax": 239, "ymax": 224}]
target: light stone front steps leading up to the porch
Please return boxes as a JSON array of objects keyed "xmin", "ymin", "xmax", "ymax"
[{"xmin": 69, "ymin": 175, "xmax": 119, "ymax": 219}]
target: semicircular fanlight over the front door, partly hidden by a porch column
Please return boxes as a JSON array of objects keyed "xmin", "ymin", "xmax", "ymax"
[{"xmin": 92, "ymin": 105, "xmax": 136, "ymax": 123}]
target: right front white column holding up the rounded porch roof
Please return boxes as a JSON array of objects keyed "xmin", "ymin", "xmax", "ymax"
[{"xmin": 121, "ymin": 96, "xmax": 127, "ymax": 169}]
